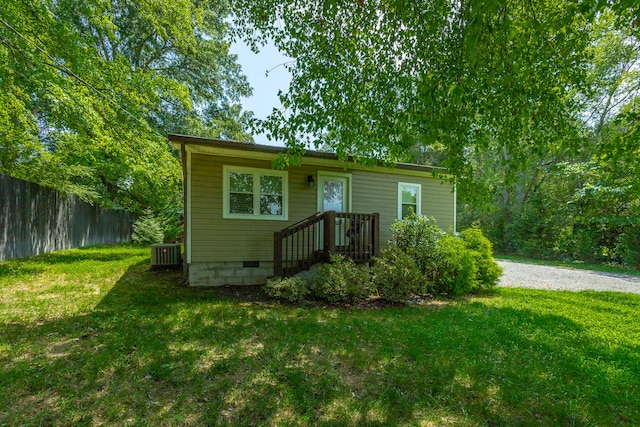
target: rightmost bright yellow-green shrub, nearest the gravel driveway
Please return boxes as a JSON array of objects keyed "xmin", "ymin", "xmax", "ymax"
[{"xmin": 460, "ymin": 226, "xmax": 502, "ymax": 288}]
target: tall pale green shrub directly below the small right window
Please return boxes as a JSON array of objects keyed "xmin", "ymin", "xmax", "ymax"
[{"xmin": 389, "ymin": 212, "xmax": 446, "ymax": 272}]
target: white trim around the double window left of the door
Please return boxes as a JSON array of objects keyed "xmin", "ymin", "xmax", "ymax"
[{"xmin": 222, "ymin": 165, "xmax": 289, "ymax": 221}]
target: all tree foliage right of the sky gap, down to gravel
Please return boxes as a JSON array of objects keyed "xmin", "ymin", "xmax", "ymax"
[{"xmin": 234, "ymin": 0, "xmax": 640, "ymax": 268}]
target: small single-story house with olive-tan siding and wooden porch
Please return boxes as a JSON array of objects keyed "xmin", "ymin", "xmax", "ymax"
[{"xmin": 169, "ymin": 134, "xmax": 456, "ymax": 286}]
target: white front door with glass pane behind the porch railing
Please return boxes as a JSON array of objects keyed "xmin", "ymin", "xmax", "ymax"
[{"xmin": 318, "ymin": 172, "xmax": 351, "ymax": 246}]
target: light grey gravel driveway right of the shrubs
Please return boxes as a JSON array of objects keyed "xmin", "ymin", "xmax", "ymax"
[{"xmin": 497, "ymin": 260, "xmax": 640, "ymax": 294}]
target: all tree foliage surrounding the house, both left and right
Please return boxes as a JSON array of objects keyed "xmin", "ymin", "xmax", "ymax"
[{"xmin": 0, "ymin": 0, "xmax": 640, "ymax": 268}]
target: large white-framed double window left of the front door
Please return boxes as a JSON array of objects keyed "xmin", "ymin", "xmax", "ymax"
[{"xmin": 222, "ymin": 166, "xmax": 288, "ymax": 220}]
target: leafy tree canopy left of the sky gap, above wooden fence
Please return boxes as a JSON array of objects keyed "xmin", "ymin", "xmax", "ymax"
[{"xmin": 0, "ymin": 0, "xmax": 251, "ymax": 211}]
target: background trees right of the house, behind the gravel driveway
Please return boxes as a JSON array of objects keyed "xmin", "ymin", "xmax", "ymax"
[{"xmin": 458, "ymin": 12, "xmax": 640, "ymax": 262}]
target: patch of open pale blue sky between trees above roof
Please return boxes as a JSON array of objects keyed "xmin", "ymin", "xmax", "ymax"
[{"xmin": 230, "ymin": 42, "xmax": 291, "ymax": 146}]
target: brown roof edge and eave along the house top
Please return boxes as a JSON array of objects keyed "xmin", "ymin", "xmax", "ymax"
[{"xmin": 167, "ymin": 133, "xmax": 447, "ymax": 174}]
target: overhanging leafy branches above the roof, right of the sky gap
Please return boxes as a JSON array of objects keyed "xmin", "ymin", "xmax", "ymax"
[{"xmin": 235, "ymin": 0, "xmax": 637, "ymax": 172}]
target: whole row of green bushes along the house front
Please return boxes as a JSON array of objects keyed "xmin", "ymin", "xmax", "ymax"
[{"xmin": 265, "ymin": 214, "xmax": 502, "ymax": 303}]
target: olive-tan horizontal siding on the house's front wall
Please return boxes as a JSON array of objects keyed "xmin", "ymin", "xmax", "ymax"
[{"xmin": 190, "ymin": 153, "xmax": 454, "ymax": 263}]
